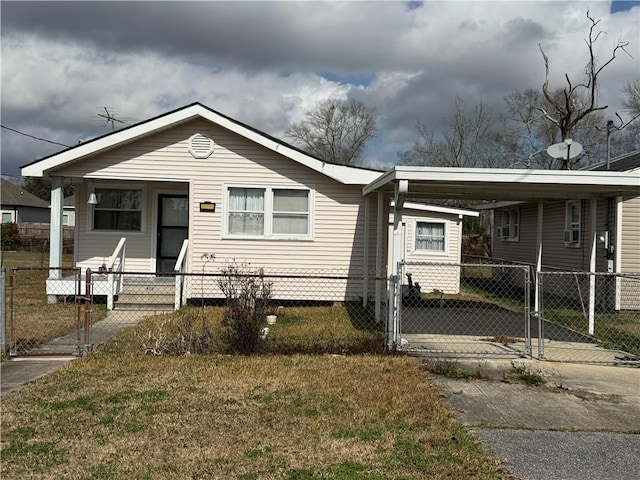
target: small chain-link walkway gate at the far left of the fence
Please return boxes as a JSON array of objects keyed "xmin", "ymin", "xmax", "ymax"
[{"xmin": 5, "ymin": 267, "xmax": 85, "ymax": 356}]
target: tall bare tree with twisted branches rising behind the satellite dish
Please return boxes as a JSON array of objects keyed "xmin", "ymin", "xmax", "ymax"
[{"xmin": 535, "ymin": 10, "xmax": 629, "ymax": 169}]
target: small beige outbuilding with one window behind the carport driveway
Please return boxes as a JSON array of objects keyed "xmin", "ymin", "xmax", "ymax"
[{"xmin": 387, "ymin": 202, "xmax": 480, "ymax": 294}]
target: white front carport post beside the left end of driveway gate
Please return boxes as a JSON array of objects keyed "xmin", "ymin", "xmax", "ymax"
[{"xmin": 387, "ymin": 180, "xmax": 409, "ymax": 349}]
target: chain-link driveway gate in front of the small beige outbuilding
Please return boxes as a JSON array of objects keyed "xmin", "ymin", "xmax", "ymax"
[{"xmin": 396, "ymin": 262, "xmax": 538, "ymax": 357}]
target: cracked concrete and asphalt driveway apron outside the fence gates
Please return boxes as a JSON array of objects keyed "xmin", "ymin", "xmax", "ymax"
[{"xmin": 420, "ymin": 359, "xmax": 640, "ymax": 480}]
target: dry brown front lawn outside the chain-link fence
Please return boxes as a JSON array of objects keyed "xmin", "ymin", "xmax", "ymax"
[{"xmin": 1, "ymin": 353, "xmax": 506, "ymax": 480}]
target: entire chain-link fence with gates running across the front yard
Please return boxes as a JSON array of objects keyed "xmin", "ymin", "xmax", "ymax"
[{"xmin": 2, "ymin": 262, "xmax": 640, "ymax": 365}]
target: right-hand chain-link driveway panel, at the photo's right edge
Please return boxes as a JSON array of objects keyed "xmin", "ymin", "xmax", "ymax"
[{"xmin": 539, "ymin": 272, "xmax": 640, "ymax": 364}]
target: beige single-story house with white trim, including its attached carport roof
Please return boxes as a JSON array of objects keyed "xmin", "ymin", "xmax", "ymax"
[{"xmin": 22, "ymin": 103, "xmax": 640, "ymax": 342}]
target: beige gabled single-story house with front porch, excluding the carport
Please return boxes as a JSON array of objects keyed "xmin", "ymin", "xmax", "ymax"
[{"xmin": 22, "ymin": 103, "xmax": 388, "ymax": 308}]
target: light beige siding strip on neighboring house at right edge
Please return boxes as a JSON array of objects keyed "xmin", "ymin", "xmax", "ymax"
[{"xmin": 620, "ymin": 197, "xmax": 640, "ymax": 310}]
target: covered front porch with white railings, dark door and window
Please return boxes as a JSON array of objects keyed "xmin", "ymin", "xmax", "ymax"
[{"xmin": 46, "ymin": 177, "xmax": 190, "ymax": 310}]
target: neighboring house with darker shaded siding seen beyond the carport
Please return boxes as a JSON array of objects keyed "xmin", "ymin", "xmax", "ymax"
[{"xmin": 488, "ymin": 151, "xmax": 640, "ymax": 310}]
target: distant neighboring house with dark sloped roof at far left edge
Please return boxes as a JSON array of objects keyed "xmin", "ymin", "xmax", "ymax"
[{"xmin": 0, "ymin": 178, "xmax": 49, "ymax": 224}]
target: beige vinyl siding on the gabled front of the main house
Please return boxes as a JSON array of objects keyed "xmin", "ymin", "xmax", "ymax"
[{"xmin": 60, "ymin": 120, "xmax": 377, "ymax": 299}]
